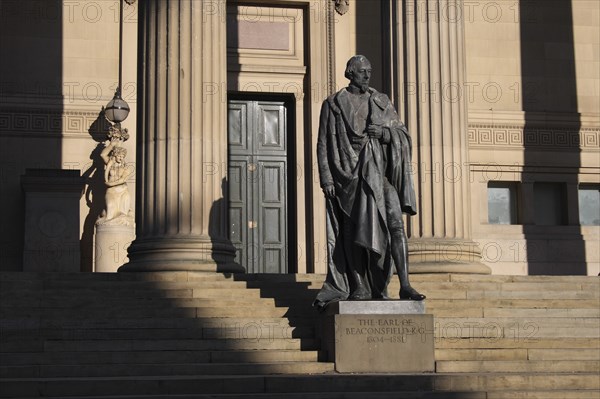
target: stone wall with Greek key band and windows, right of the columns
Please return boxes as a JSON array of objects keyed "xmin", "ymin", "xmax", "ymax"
[{"xmin": 463, "ymin": 1, "xmax": 600, "ymax": 275}]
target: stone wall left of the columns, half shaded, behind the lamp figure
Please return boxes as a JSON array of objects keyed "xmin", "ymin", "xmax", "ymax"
[{"xmin": 0, "ymin": 0, "xmax": 137, "ymax": 271}]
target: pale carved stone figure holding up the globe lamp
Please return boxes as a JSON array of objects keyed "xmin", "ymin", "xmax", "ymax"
[{"xmin": 96, "ymin": 127, "xmax": 134, "ymax": 226}]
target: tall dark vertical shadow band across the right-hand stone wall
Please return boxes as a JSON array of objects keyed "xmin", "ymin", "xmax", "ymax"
[{"xmin": 519, "ymin": 0, "xmax": 587, "ymax": 275}]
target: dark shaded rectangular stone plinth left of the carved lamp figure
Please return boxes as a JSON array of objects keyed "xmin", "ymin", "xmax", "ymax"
[{"xmin": 21, "ymin": 169, "xmax": 84, "ymax": 272}]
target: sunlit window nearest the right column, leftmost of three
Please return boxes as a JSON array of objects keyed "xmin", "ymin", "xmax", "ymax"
[{"xmin": 488, "ymin": 182, "xmax": 518, "ymax": 224}]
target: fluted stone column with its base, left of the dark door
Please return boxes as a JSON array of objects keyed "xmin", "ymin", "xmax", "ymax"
[{"xmin": 119, "ymin": 0, "xmax": 244, "ymax": 272}]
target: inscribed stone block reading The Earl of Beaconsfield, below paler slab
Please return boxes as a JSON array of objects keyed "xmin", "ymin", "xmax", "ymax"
[{"xmin": 335, "ymin": 314, "xmax": 435, "ymax": 373}]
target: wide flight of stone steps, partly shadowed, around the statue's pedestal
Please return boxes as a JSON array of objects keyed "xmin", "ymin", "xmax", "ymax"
[{"xmin": 0, "ymin": 272, "xmax": 600, "ymax": 399}]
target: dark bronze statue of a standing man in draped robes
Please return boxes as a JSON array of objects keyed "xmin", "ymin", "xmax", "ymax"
[{"xmin": 314, "ymin": 55, "xmax": 425, "ymax": 309}]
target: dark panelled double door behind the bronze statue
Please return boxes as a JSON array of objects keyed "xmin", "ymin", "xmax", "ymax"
[{"xmin": 228, "ymin": 100, "xmax": 289, "ymax": 273}]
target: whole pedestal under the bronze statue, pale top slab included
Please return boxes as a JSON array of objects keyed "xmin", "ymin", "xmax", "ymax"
[{"xmin": 320, "ymin": 301, "xmax": 435, "ymax": 373}]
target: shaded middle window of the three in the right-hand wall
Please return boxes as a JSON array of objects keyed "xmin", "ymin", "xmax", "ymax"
[{"xmin": 533, "ymin": 182, "xmax": 567, "ymax": 226}]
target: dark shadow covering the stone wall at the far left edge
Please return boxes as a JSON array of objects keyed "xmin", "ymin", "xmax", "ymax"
[{"xmin": 0, "ymin": 0, "xmax": 63, "ymax": 271}]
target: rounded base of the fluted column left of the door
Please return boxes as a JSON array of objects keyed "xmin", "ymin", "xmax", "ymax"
[{"xmin": 118, "ymin": 237, "xmax": 246, "ymax": 273}]
